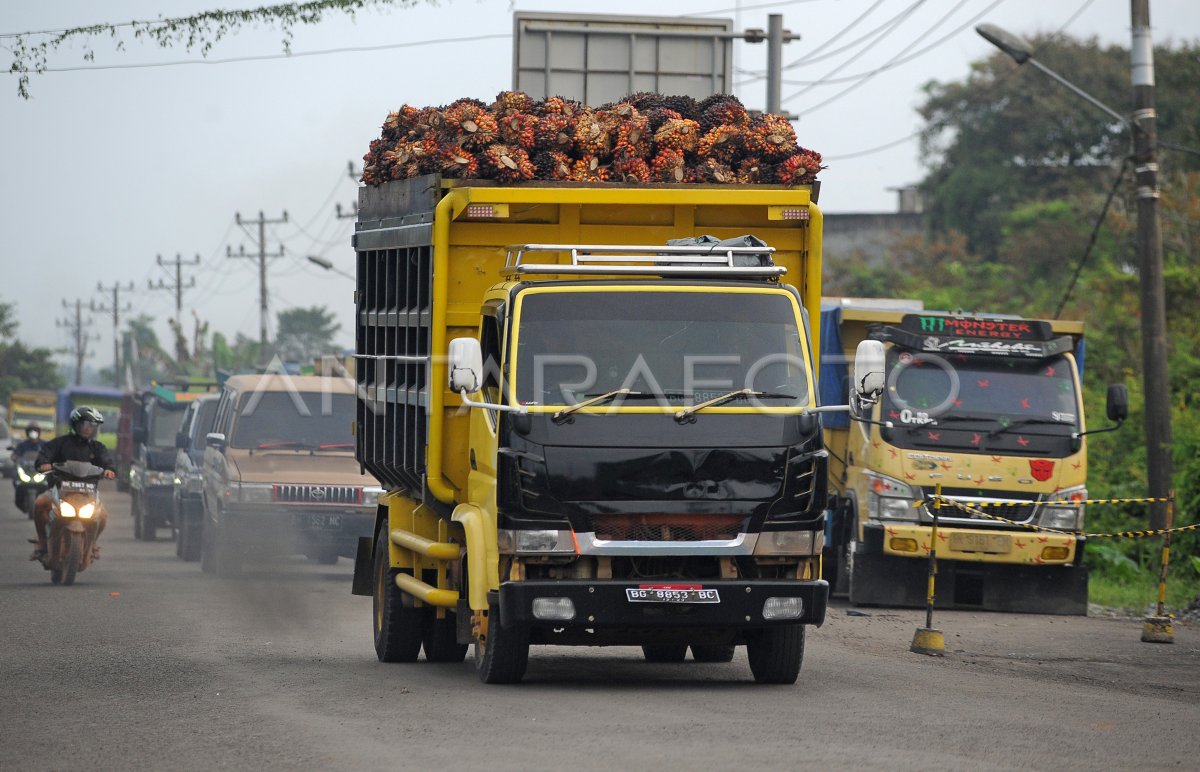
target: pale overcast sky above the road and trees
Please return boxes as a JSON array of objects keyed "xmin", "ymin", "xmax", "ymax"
[{"xmin": 0, "ymin": 0, "xmax": 1200, "ymax": 367}]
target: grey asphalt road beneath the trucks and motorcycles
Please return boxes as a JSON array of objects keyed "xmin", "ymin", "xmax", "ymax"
[{"xmin": 0, "ymin": 481, "xmax": 1200, "ymax": 771}]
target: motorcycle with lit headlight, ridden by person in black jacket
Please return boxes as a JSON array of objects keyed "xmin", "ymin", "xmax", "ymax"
[{"xmin": 41, "ymin": 461, "xmax": 107, "ymax": 585}]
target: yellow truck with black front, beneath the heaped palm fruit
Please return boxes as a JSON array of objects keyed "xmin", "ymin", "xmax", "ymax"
[{"xmin": 354, "ymin": 175, "xmax": 864, "ymax": 683}]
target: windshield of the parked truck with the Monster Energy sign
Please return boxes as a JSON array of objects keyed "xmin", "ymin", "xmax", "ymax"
[{"xmin": 882, "ymin": 348, "xmax": 1079, "ymax": 453}]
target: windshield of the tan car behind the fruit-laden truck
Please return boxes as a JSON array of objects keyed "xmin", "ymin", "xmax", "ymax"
[{"xmin": 229, "ymin": 391, "xmax": 354, "ymax": 450}]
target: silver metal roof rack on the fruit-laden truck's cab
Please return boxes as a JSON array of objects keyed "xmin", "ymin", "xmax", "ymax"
[{"xmin": 500, "ymin": 244, "xmax": 787, "ymax": 279}]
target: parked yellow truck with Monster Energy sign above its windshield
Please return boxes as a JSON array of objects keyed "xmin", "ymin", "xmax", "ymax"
[{"xmin": 821, "ymin": 299, "xmax": 1127, "ymax": 615}]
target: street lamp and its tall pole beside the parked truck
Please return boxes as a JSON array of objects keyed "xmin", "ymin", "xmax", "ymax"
[{"xmin": 976, "ymin": 13, "xmax": 1171, "ymax": 528}]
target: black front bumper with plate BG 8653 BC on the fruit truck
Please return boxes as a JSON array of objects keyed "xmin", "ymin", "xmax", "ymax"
[{"xmin": 499, "ymin": 580, "xmax": 829, "ymax": 640}]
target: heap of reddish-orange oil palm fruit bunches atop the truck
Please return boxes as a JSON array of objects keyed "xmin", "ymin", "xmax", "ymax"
[{"xmin": 362, "ymin": 91, "xmax": 824, "ymax": 185}]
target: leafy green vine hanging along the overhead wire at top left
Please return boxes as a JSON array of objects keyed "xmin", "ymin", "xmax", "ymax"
[{"xmin": 7, "ymin": 0, "xmax": 432, "ymax": 100}]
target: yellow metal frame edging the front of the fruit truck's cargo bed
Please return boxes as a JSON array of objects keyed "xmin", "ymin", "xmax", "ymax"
[{"xmin": 417, "ymin": 180, "xmax": 823, "ymax": 506}]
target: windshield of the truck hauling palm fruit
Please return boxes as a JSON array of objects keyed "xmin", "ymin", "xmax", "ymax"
[{"xmin": 515, "ymin": 289, "xmax": 809, "ymax": 407}]
